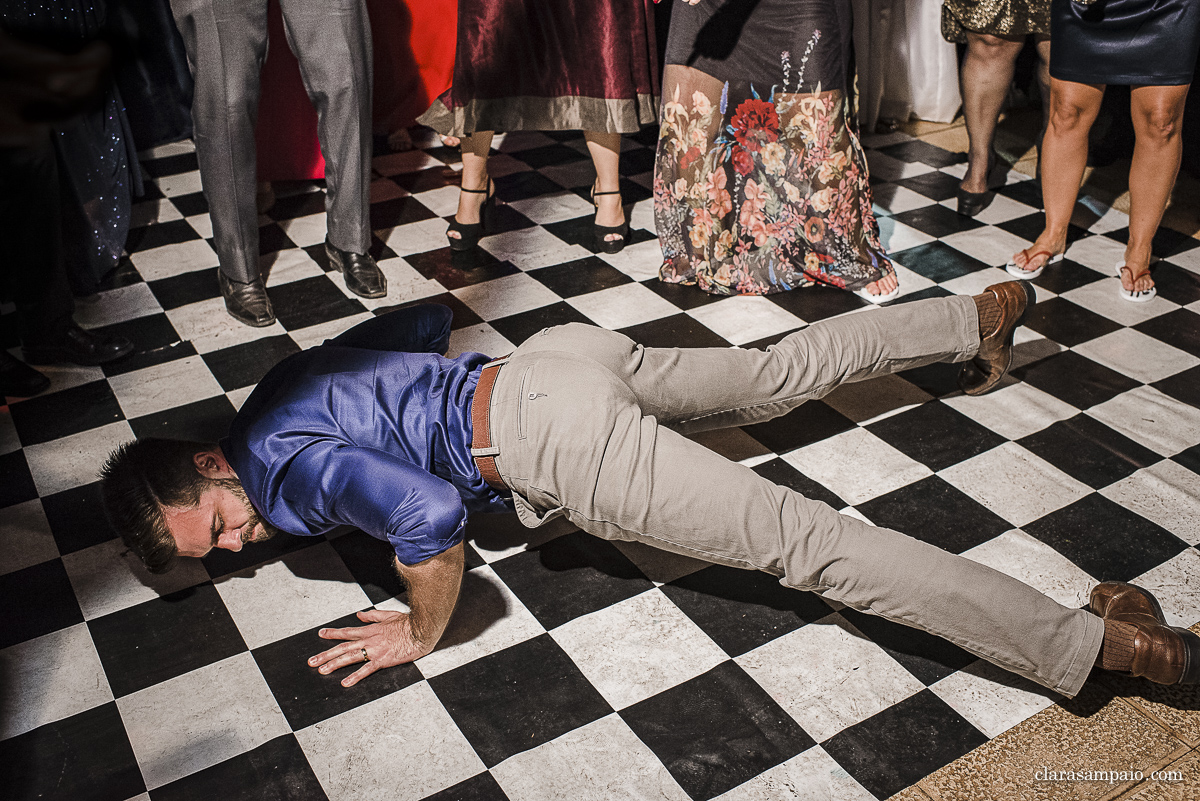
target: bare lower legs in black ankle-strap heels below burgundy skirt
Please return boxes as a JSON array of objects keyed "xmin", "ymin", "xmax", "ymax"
[{"xmin": 446, "ymin": 131, "xmax": 625, "ymax": 242}]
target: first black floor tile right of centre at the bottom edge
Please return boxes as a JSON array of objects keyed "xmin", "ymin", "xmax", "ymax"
[{"xmin": 620, "ymin": 662, "xmax": 815, "ymax": 801}]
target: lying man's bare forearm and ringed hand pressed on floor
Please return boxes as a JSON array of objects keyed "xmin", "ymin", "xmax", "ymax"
[{"xmin": 308, "ymin": 542, "xmax": 463, "ymax": 687}]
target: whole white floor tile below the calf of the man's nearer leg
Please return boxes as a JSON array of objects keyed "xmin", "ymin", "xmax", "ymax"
[{"xmin": 734, "ymin": 614, "xmax": 925, "ymax": 742}]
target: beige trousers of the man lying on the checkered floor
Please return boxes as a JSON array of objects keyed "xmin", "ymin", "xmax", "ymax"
[{"xmin": 491, "ymin": 296, "xmax": 1104, "ymax": 695}]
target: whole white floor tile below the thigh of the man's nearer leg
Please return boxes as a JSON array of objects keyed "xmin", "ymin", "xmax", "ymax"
[{"xmin": 551, "ymin": 590, "xmax": 728, "ymax": 710}]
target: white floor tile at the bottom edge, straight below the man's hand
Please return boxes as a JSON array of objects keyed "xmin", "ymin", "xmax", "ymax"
[{"xmin": 296, "ymin": 681, "xmax": 484, "ymax": 801}]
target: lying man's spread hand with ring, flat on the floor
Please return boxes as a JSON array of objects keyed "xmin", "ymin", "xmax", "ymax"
[{"xmin": 308, "ymin": 609, "xmax": 437, "ymax": 687}]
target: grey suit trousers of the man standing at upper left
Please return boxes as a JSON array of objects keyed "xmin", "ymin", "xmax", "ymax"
[{"xmin": 170, "ymin": 0, "xmax": 371, "ymax": 282}]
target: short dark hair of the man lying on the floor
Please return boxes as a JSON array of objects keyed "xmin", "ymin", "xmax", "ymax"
[{"xmin": 100, "ymin": 436, "xmax": 216, "ymax": 573}]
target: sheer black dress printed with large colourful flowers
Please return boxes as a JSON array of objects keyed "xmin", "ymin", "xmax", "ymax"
[{"xmin": 654, "ymin": 0, "xmax": 894, "ymax": 295}]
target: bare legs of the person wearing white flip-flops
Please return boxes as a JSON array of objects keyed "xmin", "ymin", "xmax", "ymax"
[{"xmin": 1013, "ymin": 77, "xmax": 1189, "ymax": 293}]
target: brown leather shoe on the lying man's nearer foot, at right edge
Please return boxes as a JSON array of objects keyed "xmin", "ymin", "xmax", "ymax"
[{"xmin": 1088, "ymin": 582, "xmax": 1200, "ymax": 685}]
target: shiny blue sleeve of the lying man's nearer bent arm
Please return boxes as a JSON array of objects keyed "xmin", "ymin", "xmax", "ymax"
[{"xmin": 278, "ymin": 440, "xmax": 467, "ymax": 565}]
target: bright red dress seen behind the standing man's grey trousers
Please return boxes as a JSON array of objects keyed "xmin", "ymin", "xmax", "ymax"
[{"xmin": 258, "ymin": 0, "xmax": 458, "ymax": 181}]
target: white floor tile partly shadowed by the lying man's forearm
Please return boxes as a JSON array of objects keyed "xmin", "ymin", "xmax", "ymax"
[{"xmin": 408, "ymin": 565, "xmax": 546, "ymax": 679}]
